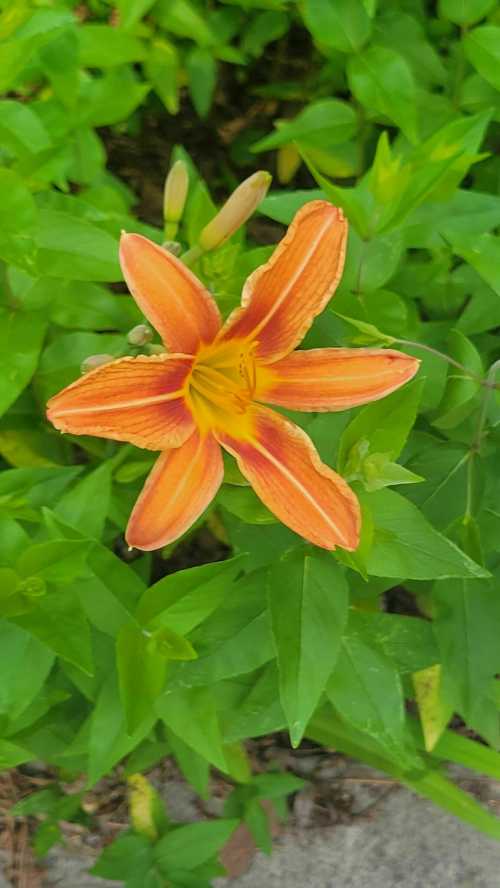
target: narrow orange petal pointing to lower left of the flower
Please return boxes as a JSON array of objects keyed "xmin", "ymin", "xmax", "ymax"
[{"xmin": 126, "ymin": 432, "xmax": 224, "ymax": 550}]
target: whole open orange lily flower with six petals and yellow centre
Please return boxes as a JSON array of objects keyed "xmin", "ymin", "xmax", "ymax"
[{"xmin": 48, "ymin": 201, "xmax": 419, "ymax": 550}]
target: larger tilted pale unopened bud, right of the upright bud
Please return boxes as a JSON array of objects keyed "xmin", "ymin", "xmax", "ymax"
[{"xmin": 199, "ymin": 170, "xmax": 272, "ymax": 251}]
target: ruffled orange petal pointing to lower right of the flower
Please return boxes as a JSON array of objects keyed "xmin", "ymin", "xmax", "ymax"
[{"xmin": 216, "ymin": 405, "xmax": 360, "ymax": 550}]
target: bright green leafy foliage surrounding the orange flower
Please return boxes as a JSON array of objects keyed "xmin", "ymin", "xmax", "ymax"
[{"xmin": 0, "ymin": 0, "xmax": 500, "ymax": 888}]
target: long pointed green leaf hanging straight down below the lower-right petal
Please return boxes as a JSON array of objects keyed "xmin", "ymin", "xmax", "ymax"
[{"xmin": 269, "ymin": 552, "xmax": 349, "ymax": 747}]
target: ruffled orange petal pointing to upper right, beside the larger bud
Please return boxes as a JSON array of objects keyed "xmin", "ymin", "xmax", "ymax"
[{"xmin": 220, "ymin": 200, "xmax": 347, "ymax": 363}]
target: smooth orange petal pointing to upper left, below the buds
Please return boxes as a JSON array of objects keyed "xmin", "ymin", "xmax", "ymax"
[{"xmin": 120, "ymin": 234, "xmax": 220, "ymax": 355}]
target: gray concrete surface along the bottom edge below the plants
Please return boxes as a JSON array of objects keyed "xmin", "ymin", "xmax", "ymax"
[{"xmin": 0, "ymin": 784, "xmax": 500, "ymax": 888}]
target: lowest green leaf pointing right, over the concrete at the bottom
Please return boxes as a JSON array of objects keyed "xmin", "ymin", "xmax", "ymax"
[{"xmin": 154, "ymin": 818, "xmax": 239, "ymax": 876}]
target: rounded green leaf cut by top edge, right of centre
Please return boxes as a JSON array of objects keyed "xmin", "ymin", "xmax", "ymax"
[{"xmin": 303, "ymin": 0, "xmax": 371, "ymax": 53}]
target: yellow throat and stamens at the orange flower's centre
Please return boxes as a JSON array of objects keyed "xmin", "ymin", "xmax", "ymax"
[{"xmin": 188, "ymin": 341, "xmax": 256, "ymax": 429}]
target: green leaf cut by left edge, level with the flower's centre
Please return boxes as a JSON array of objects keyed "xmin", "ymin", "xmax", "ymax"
[{"xmin": 0, "ymin": 308, "xmax": 47, "ymax": 413}]
